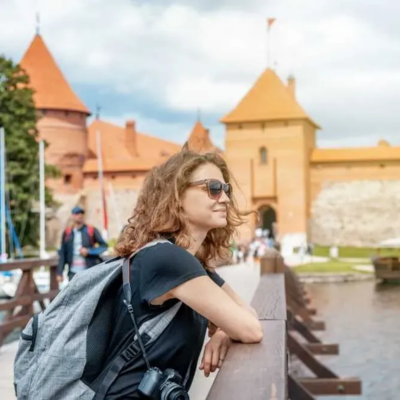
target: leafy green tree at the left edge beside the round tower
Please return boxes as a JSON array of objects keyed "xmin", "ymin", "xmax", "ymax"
[{"xmin": 0, "ymin": 56, "xmax": 58, "ymax": 252}]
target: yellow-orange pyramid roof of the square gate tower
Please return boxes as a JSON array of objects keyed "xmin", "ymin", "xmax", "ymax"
[{"xmin": 221, "ymin": 68, "xmax": 319, "ymax": 128}]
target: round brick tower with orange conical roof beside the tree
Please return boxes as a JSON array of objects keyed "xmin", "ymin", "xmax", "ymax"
[{"xmin": 20, "ymin": 34, "xmax": 90, "ymax": 194}]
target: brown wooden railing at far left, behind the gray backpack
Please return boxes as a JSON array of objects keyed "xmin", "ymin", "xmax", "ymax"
[{"xmin": 0, "ymin": 258, "xmax": 59, "ymax": 346}]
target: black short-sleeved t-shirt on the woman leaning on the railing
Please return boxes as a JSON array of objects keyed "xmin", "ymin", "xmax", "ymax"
[{"xmin": 106, "ymin": 243, "xmax": 224, "ymax": 400}]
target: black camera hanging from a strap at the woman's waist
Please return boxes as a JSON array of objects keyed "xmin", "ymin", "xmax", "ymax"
[{"xmin": 138, "ymin": 367, "xmax": 189, "ymax": 400}]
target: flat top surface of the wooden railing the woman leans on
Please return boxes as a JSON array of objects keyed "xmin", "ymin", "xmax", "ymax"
[{"xmin": 207, "ymin": 274, "xmax": 288, "ymax": 400}]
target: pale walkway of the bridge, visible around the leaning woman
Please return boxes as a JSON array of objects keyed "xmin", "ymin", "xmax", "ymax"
[{"xmin": 0, "ymin": 264, "xmax": 260, "ymax": 400}]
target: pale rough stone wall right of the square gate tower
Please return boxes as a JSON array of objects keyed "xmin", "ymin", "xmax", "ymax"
[{"xmin": 310, "ymin": 180, "xmax": 400, "ymax": 246}]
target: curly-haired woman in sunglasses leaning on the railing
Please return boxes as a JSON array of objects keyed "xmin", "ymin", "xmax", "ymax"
[{"xmin": 106, "ymin": 149, "xmax": 263, "ymax": 399}]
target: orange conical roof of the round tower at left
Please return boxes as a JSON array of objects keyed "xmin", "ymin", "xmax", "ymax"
[{"xmin": 20, "ymin": 35, "xmax": 90, "ymax": 115}]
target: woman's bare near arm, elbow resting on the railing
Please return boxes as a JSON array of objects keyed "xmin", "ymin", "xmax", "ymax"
[{"xmin": 166, "ymin": 276, "xmax": 263, "ymax": 343}]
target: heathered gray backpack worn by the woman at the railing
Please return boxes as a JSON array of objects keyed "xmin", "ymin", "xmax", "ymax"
[{"xmin": 14, "ymin": 240, "xmax": 182, "ymax": 400}]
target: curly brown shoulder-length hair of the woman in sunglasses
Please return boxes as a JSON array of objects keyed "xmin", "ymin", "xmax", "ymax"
[{"xmin": 115, "ymin": 145, "xmax": 250, "ymax": 268}]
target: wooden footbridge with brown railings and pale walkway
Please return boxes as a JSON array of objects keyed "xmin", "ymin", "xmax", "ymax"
[{"xmin": 0, "ymin": 251, "xmax": 361, "ymax": 400}]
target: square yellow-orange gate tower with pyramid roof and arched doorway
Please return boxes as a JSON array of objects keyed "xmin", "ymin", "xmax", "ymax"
[{"xmin": 222, "ymin": 68, "xmax": 319, "ymax": 241}]
